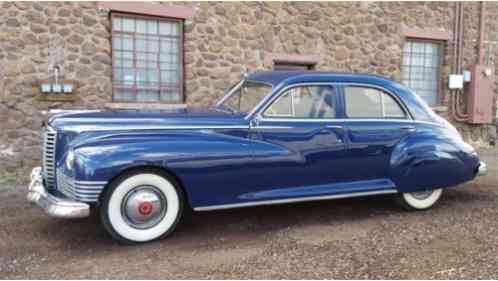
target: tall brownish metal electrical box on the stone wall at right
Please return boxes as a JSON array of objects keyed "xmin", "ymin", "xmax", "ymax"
[{"xmin": 467, "ymin": 64, "xmax": 495, "ymax": 124}]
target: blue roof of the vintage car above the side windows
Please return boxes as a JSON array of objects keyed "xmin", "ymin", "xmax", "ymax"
[{"xmin": 247, "ymin": 71, "xmax": 398, "ymax": 87}]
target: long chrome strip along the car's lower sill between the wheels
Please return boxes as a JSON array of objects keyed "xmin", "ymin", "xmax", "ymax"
[{"xmin": 194, "ymin": 189, "xmax": 398, "ymax": 212}]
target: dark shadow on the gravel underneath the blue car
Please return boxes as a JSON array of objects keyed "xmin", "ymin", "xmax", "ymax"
[{"xmin": 35, "ymin": 188, "xmax": 488, "ymax": 250}]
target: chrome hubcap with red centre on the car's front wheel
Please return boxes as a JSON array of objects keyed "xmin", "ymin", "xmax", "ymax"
[{"xmin": 121, "ymin": 186, "xmax": 167, "ymax": 229}]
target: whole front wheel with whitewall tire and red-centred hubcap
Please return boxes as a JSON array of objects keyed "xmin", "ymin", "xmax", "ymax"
[{"xmin": 100, "ymin": 172, "xmax": 183, "ymax": 243}]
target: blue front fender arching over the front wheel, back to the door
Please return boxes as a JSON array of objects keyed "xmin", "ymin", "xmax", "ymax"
[{"xmin": 72, "ymin": 130, "xmax": 255, "ymax": 184}]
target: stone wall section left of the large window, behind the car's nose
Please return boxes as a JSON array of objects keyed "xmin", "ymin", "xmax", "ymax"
[{"xmin": 0, "ymin": 2, "xmax": 111, "ymax": 178}]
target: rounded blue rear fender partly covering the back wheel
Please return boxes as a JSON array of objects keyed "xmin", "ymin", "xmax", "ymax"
[{"xmin": 390, "ymin": 125, "xmax": 479, "ymax": 192}]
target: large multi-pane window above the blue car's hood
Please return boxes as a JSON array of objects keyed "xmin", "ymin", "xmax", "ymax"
[{"xmin": 112, "ymin": 15, "xmax": 183, "ymax": 103}]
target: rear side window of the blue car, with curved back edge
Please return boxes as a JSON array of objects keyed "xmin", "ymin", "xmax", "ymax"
[{"xmin": 344, "ymin": 86, "xmax": 406, "ymax": 118}]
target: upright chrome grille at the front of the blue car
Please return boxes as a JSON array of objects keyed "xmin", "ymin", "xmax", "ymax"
[{"xmin": 43, "ymin": 126, "xmax": 57, "ymax": 189}]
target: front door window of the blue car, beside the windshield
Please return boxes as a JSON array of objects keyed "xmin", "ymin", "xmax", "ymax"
[{"xmin": 263, "ymin": 86, "xmax": 336, "ymax": 119}]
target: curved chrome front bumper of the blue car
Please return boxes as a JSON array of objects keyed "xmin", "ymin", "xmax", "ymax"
[{"xmin": 28, "ymin": 167, "xmax": 90, "ymax": 219}]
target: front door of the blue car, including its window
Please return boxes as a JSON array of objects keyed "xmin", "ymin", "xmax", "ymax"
[{"xmin": 246, "ymin": 84, "xmax": 346, "ymax": 199}]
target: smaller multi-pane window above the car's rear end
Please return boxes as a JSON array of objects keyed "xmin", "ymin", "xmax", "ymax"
[{"xmin": 402, "ymin": 40, "xmax": 442, "ymax": 106}]
